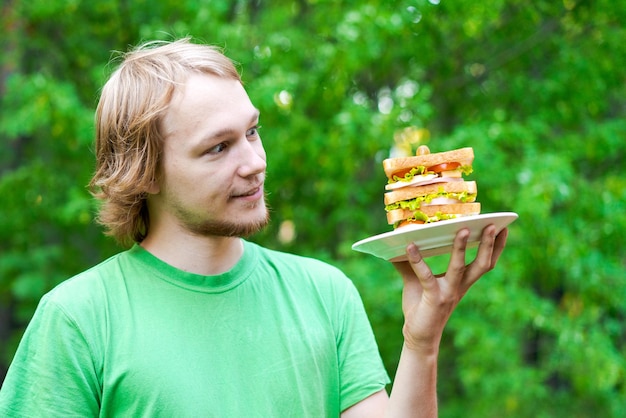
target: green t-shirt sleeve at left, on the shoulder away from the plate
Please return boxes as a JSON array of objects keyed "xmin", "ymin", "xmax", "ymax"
[{"xmin": 0, "ymin": 297, "xmax": 100, "ymax": 417}]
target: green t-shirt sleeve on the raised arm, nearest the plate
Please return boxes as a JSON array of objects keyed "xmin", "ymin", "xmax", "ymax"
[{"xmin": 337, "ymin": 281, "xmax": 390, "ymax": 411}]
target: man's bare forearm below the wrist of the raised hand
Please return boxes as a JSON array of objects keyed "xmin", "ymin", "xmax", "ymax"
[{"xmin": 386, "ymin": 344, "xmax": 438, "ymax": 418}]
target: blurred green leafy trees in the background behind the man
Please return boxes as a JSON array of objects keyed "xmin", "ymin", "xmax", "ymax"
[{"xmin": 0, "ymin": 0, "xmax": 626, "ymax": 418}]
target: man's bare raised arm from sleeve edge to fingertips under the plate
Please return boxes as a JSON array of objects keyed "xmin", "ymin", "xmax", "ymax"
[{"xmin": 341, "ymin": 225, "xmax": 508, "ymax": 418}]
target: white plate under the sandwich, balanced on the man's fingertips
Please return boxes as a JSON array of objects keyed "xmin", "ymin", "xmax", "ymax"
[{"xmin": 352, "ymin": 212, "xmax": 518, "ymax": 261}]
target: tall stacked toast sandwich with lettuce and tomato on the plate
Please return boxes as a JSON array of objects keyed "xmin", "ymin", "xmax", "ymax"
[{"xmin": 383, "ymin": 145, "xmax": 480, "ymax": 228}]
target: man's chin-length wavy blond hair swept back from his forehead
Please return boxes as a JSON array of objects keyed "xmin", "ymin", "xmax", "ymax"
[{"xmin": 89, "ymin": 38, "xmax": 241, "ymax": 245}]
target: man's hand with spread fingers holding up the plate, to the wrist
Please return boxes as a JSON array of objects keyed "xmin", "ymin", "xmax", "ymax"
[{"xmin": 394, "ymin": 225, "xmax": 508, "ymax": 355}]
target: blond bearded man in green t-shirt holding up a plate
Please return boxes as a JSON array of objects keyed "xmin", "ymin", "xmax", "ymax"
[{"xmin": 0, "ymin": 40, "xmax": 507, "ymax": 418}]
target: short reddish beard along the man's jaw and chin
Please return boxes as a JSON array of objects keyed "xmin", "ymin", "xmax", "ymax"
[{"xmin": 178, "ymin": 193, "xmax": 270, "ymax": 238}]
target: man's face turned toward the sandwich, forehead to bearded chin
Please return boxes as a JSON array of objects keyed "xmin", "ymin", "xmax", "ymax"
[{"xmin": 148, "ymin": 74, "xmax": 268, "ymax": 236}]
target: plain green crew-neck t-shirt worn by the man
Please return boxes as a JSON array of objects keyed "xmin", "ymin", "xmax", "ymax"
[{"xmin": 0, "ymin": 241, "xmax": 389, "ymax": 418}]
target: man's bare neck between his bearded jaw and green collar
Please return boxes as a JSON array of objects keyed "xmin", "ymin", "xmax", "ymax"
[{"xmin": 141, "ymin": 233, "xmax": 243, "ymax": 276}]
